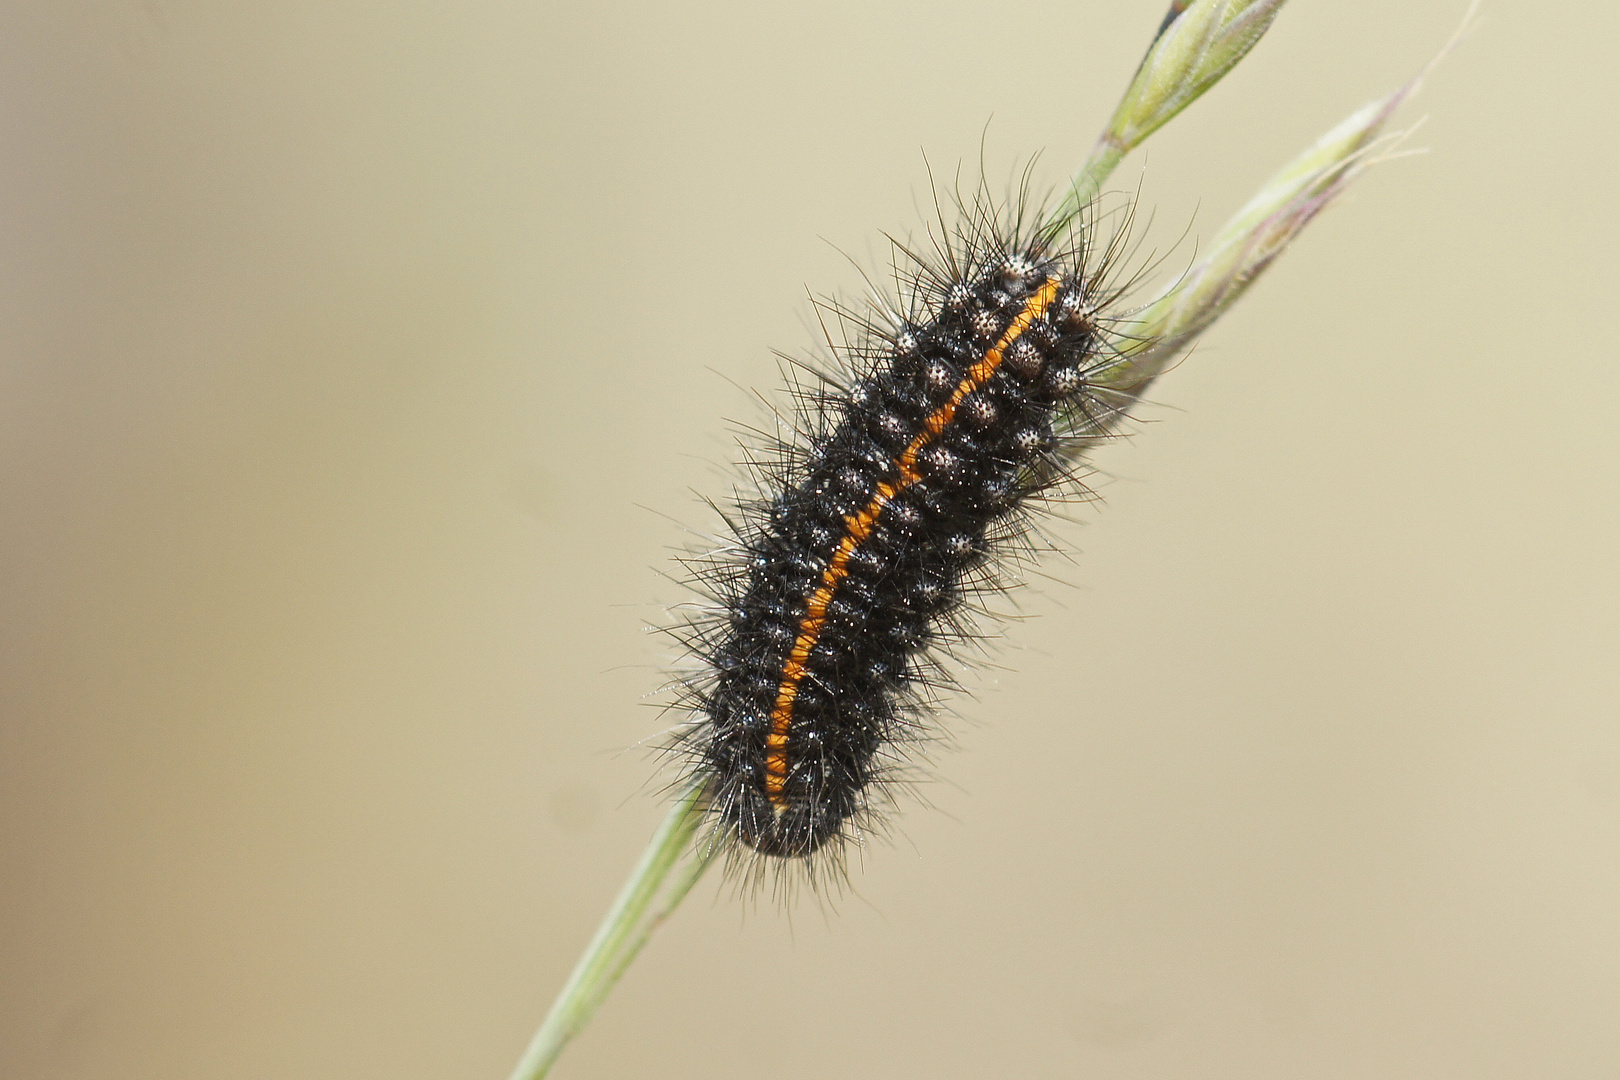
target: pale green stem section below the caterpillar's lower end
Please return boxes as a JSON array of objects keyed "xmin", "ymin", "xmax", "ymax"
[{"xmin": 512, "ymin": 784, "xmax": 713, "ymax": 1080}]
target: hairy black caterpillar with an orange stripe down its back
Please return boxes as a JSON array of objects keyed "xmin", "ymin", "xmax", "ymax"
[{"xmin": 664, "ymin": 202, "xmax": 1118, "ymax": 858}]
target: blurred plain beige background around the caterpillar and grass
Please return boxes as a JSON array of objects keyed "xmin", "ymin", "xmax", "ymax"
[{"xmin": 0, "ymin": 0, "xmax": 1620, "ymax": 1080}]
